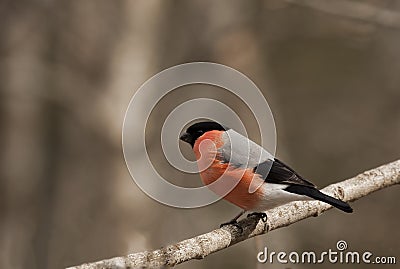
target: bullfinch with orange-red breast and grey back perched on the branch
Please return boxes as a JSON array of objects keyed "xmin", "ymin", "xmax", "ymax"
[{"xmin": 180, "ymin": 121, "xmax": 353, "ymax": 226}]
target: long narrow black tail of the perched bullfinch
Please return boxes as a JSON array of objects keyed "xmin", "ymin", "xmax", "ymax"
[{"xmin": 284, "ymin": 185, "xmax": 353, "ymax": 213}]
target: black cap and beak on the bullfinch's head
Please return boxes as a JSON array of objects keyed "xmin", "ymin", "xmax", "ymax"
[{"xmin": 179, "ymin": 121, "xmax": 229, "ymax": 148}]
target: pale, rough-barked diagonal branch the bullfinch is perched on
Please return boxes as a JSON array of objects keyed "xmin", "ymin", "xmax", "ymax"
[{"xmin": 69, "ymin": 160, "xmax": 400, "ymax": 269}]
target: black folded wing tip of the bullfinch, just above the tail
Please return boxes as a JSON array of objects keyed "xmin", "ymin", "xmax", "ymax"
[{"xmin": 253, "ymin": 158, "xmax": 315, "ymax": 188}]
